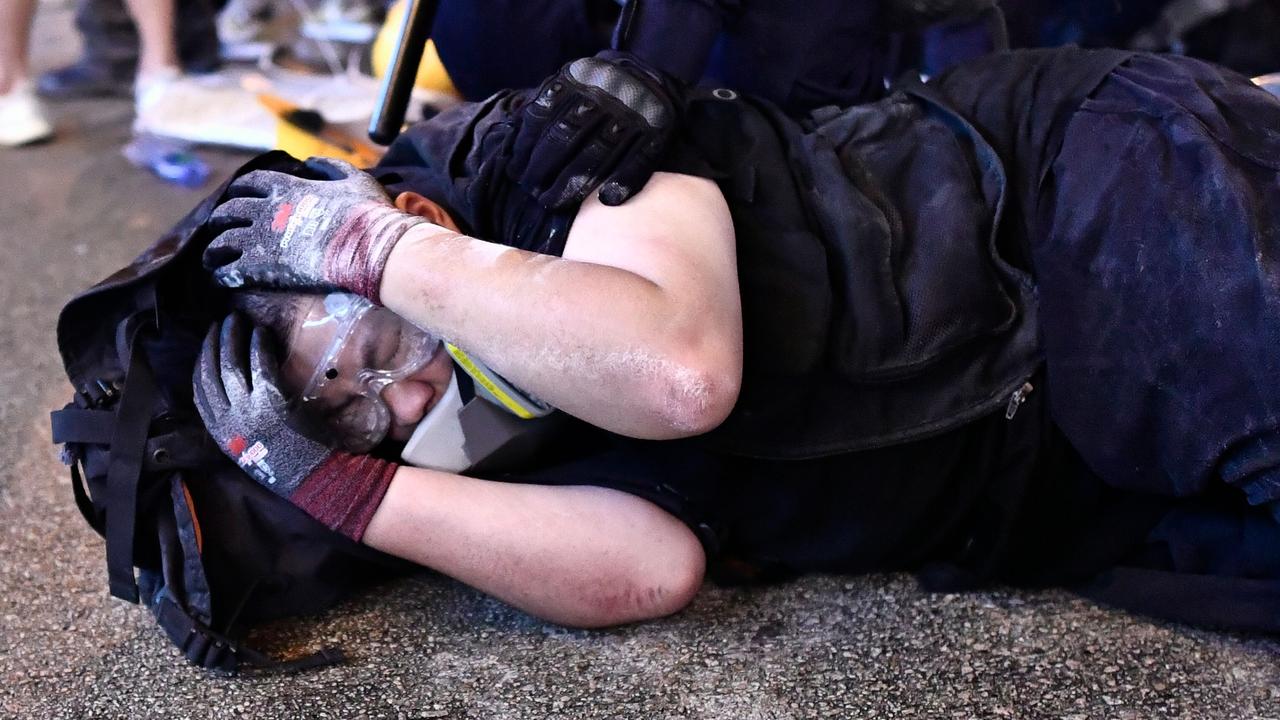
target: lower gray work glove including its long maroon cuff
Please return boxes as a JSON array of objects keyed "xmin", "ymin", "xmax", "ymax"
[{"xmin": 193, "ymin": 314, "xmax": 398, "ymax": 541}]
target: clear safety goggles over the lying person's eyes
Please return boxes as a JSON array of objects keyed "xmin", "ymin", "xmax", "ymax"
[{"xmin": 285, "ymin": 292, "xmax": 442, "ymax": 452}]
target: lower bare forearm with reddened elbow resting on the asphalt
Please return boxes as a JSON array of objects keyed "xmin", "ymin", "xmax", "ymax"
[{"xmin": 364, "ymin": 468, "xmax": 704, "ymax": 626}]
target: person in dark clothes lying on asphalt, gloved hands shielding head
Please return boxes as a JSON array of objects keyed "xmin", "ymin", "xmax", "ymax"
[{"xmin": 196, "ymin": 49, "xmax": 1280, "ymax": 630}]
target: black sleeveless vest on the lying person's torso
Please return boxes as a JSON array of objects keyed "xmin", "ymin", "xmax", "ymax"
[{"xmin": 383, "ymin": 47, "xmax": 1123, "ymax": 459}]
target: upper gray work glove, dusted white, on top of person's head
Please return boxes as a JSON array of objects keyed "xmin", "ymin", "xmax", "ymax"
[{"xmin": 204, "ymin": 158, "xmax": 426, "ymax": 302}]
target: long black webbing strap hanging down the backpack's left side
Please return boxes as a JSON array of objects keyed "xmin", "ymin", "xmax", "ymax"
[{"xmin": 106, "ymin": 333, "xmax": 157, "ymax": 602}]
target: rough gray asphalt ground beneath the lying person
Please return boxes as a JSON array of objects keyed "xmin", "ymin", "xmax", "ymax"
[{"xmin": 0, "ymin": 9, "xmax": 1280, "ymax": 720}]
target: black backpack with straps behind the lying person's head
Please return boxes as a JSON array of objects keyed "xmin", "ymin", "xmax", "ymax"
[{"xmin": 51, "ymin": 152, "xmax": 408, "ymax": 673}]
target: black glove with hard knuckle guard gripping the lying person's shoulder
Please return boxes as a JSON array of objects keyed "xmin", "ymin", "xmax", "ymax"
[{"xmin": 507, "ymin": 50, "xmax": 681, "ymax": 210}]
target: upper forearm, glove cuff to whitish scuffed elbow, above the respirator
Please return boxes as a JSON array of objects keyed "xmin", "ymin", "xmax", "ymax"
[{"xmin": 381, "ymin": 225, "xmax": 736, "ymax": 439}]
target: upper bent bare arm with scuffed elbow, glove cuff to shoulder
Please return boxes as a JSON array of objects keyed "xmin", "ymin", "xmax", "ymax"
[{"xmin": 380, "ymin": 173, "xmax": 742, "ymax": 439}]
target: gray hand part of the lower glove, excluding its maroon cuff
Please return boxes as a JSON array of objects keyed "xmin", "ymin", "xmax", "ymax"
[{"xmin": 195, "ymin": 314, "xmax": 333, "ymax": 498}]
